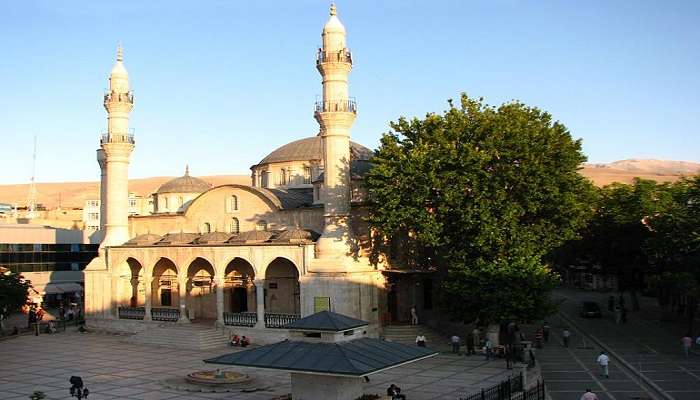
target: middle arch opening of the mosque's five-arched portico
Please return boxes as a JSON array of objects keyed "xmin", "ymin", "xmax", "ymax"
[{"xmin": 186, "ymin": 257, "xmax": 217, "ymax": 321}]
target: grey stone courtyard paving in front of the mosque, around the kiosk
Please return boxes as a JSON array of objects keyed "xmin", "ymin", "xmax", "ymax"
[{"xmin": 0, "ymin": 330, "xmax": 517, "ymax": 400}]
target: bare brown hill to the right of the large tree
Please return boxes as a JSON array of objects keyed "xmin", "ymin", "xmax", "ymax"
[{"xmin": 580, "ymin": 159, "xmax": 700, "ymax": 186}]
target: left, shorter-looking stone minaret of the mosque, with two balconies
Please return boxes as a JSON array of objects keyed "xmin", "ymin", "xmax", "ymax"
[{"xmin": 97, "ymin": 46, "xmax": 134, "ymax": 248}]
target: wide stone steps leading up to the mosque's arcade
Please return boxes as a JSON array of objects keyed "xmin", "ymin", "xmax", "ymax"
[{"xmin": 125, "ymin": 323, "xmax": 228, "ymax": 350}]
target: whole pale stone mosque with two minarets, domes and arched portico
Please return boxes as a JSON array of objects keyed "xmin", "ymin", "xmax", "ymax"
[{"xmin": 85, "ymin": 6, "xmax": 430, "ymax": 340}]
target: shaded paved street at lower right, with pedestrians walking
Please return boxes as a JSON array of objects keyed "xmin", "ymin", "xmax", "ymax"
[{"xmin": 539, "ymin": 290, "xmax": 700, "ymax": 400}]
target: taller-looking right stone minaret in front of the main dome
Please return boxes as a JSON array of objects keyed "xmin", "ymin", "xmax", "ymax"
[{"xmin": 314, "ymin": 4, "xmax": 356, "ymax": 259}]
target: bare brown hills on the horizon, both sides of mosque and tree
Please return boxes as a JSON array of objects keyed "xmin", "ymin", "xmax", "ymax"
[{"xmin": 0, "ymin": 160, "xmax": 700, "ymax": 208}]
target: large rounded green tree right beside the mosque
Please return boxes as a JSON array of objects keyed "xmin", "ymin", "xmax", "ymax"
[{"xmin": 366, "ymin": 95, "xmax": 593, "ymax": 322}]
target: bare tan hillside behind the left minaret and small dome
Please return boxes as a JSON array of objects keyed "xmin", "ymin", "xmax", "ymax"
[{"xmin": 0, "ymin": 175, "xmax": 250, "ymax": 208}]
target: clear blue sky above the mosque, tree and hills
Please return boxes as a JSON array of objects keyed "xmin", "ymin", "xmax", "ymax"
[{"xmin": 0, "ymin": 0, "xmax": 700, "ymax": 183}]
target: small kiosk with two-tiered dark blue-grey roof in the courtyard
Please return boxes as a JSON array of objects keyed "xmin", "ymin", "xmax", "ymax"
[{"xmin": 204, "ymin": 311, "xmax": 438, "ymax": 400}]
